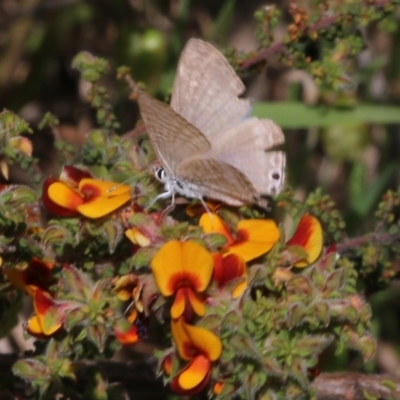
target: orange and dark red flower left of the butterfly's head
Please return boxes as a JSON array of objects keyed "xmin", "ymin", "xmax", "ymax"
[{"xmin": 42, "ymin": 166, "xmax": 131, "ymax": 218}]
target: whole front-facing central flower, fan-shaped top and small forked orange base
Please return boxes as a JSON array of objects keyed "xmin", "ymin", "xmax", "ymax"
[{"xmin": 151, "ymin": 240, "xmax": 213, "ymax": 320}]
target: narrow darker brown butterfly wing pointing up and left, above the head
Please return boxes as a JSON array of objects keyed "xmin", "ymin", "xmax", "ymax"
[{"xmin": 137, "ymin": 90, "xmax": 210, "ymax": 174}]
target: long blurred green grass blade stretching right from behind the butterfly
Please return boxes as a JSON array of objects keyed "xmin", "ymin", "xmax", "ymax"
[{"xmin": 253, "ymin": 101, "xmax": 400, "ymax": 129}]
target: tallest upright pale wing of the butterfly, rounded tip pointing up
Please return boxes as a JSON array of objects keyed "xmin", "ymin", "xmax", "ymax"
[{"xmin": 171, "ymin": 39, "xmax": 251, "ymax": 142}]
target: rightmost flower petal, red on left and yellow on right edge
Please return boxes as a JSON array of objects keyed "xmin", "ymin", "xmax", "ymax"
[{"xmin": 286, "ymin": 214, "xmax": 323, "ymax": 267}]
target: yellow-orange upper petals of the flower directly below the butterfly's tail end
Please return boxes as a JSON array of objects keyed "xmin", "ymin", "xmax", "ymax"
[{"xmin": 199, "ymin": 213, "xmax": 280, "ymax": 262}]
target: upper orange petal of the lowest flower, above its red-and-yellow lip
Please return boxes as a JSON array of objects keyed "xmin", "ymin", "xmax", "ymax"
[{"xmin": 171, "ymin": 318, "xmax": 222, "ymax": 361}]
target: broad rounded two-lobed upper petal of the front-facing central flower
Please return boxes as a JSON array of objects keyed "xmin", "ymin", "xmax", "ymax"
[{"xmin": 151, "ymin": 240, "xmax": 213, "ymax": 296}]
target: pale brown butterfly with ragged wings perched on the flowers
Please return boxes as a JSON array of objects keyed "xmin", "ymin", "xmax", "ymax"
[{"xmin": 136, "ymin": 39, "xmax": 286, "ymax": 207}]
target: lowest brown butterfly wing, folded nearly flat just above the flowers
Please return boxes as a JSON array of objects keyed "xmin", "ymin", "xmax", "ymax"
[{"xmin": 176, "ymin": 157, "xmax": 262, "ymax": 206}]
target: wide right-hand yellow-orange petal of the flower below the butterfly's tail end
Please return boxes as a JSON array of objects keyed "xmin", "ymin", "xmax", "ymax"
[{"xmin": 225, "ymin": 219, "xmax": 279, "ymax": 262}]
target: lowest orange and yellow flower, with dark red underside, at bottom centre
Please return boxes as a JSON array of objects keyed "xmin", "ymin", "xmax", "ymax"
[{"xmin": 171, "ymin": 318, "xmax": 222, "ymax": 395}]
